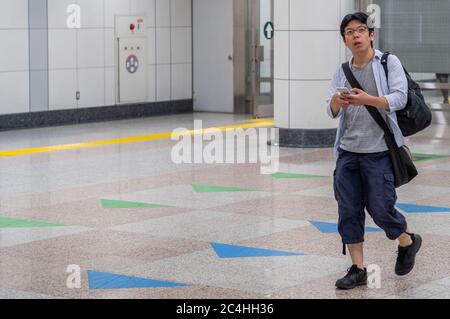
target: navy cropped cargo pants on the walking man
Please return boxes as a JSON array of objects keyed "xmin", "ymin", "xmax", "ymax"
[{"xmin": 334, "ymin": 149, "xmax": 407, "ymax": 248}]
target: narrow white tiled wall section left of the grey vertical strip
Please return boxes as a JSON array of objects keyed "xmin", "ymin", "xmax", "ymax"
[{"xmin": 0, "ymin": 0, "xmax": 30, "ymax": 115}]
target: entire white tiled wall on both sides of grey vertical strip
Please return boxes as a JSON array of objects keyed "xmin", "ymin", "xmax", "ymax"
[{"xmin": 0, "ymin": 0, "xmax": 192, "ymax": 114}]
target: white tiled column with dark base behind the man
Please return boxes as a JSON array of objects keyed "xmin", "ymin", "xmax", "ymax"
[{"xmin": 274, "ymin": 0, "xmax": 355, "ymax": 147}]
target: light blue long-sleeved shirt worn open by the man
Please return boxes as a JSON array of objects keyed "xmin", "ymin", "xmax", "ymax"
[{"xmin": 326, "ymin": 50, "xmax": 408, "ymax": 157}]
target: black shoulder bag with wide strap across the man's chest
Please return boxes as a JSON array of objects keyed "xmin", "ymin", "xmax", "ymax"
[{"xmin": 342, "ymin": 62, "xmax": 418, "ymax": 187}]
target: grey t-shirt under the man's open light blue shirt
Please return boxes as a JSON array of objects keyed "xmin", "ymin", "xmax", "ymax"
[{"xmin": 340, "ymin": 60, "xmax": 388, "ymax": 154}]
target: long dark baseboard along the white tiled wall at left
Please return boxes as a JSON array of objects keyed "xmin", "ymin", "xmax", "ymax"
[{"xmin": 0, "ymin": 99, "xmax": 193, "ymax": 131}]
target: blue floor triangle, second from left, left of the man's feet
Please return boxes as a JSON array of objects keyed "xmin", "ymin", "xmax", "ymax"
[{"xmin": 211, "ymin": 243, "xmax": 305, "ymax": 258}]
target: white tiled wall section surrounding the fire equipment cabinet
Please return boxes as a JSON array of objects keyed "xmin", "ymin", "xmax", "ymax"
[{"xmin": 48, "ymin": 0, "xmax": 192, "ymax": 110}]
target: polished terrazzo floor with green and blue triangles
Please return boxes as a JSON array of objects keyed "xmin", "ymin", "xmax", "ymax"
[{"xmin": 0, "ymin": 113, "xmax": 450, "ymax": 299}]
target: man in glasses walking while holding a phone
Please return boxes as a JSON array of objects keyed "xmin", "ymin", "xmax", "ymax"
[{"xmin": 326, "ymin": 12, "xmax": 422, "ymax": 289}]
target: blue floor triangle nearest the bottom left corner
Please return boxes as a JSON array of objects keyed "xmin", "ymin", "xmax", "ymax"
[{"xmin": 87, "ymin": 270, "xmax": 190, "ymax": 289}]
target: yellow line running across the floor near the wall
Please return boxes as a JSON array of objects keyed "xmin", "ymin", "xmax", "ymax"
[{"xmin": 0, "ymin": 120, "xmax": 274, "ymax": 157}]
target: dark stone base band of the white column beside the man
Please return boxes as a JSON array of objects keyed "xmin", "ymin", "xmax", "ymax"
[{"xmin": 279, "ymin": 128, "xmax": 337, "ymax": 148}]
